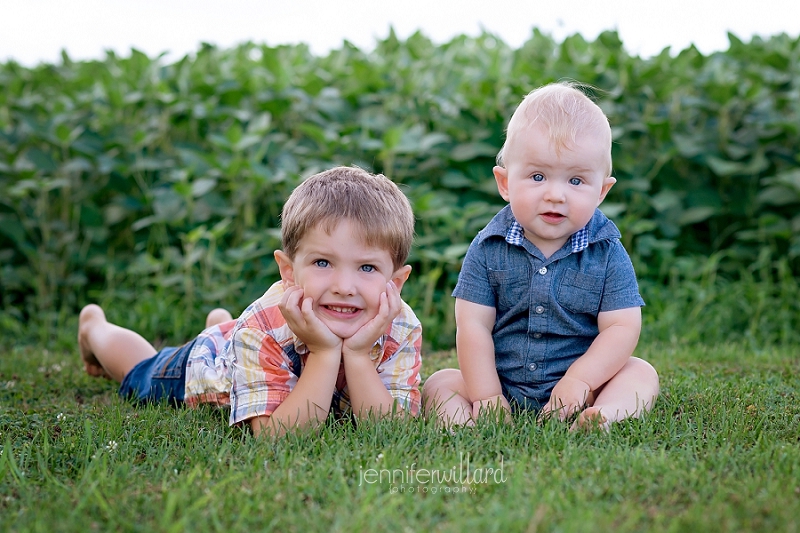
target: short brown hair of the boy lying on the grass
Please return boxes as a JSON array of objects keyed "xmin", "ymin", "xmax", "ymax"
[{"xmin": 281, "ymin": 167, "xmax": 414, "ymax": 269}]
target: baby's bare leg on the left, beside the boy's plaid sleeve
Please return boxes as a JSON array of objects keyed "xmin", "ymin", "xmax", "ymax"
[{"xmin": 422, "ymin": 368, "xmax": 472, "ymax": 427}]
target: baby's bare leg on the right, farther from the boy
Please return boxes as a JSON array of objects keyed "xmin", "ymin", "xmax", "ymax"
[{"xmin": 573, "ymin": 357, "xmax": 658, "ymax": 429}]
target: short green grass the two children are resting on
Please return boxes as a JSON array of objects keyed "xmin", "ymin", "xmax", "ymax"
[{"xmin": 0, "ymin": 332, "xmax": 800, "ymax": 532}]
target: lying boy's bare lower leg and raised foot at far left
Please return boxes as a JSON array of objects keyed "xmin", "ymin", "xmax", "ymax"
[{"xmin": 78, "ymin": 304, "xmax": 156, "ymax": 382}]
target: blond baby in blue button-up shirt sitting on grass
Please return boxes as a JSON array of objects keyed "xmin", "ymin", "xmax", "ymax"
[{"xmin": 423, "ymin": 84, "xmax": 658, "ymax": 427}]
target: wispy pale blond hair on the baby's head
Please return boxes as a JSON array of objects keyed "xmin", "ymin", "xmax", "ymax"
[{"xmin": 497, "ymin": 82, "xmax": 611, "ymax": 176}]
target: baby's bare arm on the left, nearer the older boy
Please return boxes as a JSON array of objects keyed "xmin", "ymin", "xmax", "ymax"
[{"xmin": 456, "ymin": 298, "xmax": 511, "ymax": 418}]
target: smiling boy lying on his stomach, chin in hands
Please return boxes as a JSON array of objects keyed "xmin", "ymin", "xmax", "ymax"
[{"xmin": 78, "ymin": 167, "xmax": 422, "ymax": 435}]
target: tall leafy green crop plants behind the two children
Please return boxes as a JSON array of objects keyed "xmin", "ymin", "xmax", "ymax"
[{"xmin": 0, "ymin": 30, "xmax": 800, "ymax": 346}]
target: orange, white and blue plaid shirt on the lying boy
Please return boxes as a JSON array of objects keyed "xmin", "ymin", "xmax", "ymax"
[{"xmin": 185, "ymin": 282, "xmax": 422, "ymax": 424}]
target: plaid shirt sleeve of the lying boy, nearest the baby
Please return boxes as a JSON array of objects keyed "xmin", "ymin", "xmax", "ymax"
[{"xmin": 377, "ymin": 302, "xmax": 422, "ymax": 415}]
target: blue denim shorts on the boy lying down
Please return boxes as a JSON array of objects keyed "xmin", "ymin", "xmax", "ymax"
[{"xmin": 119, "ymin": 339, "xmax": 197, "ymax": 405}]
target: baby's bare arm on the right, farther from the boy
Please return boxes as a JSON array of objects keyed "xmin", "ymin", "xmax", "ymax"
[{"xmin": 542, "ymin": 307, "xmax": 642, "ymax": 420}]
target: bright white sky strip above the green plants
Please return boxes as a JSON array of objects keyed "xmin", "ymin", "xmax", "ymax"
[{"xmin": 0, "ymin": 0, "xmax": 800, "ymax": 66}]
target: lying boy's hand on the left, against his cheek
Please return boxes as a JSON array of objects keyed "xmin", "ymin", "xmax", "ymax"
[{"xmin": 278, "ymin": 285, "xmax": 342, "ymax": 354}]
